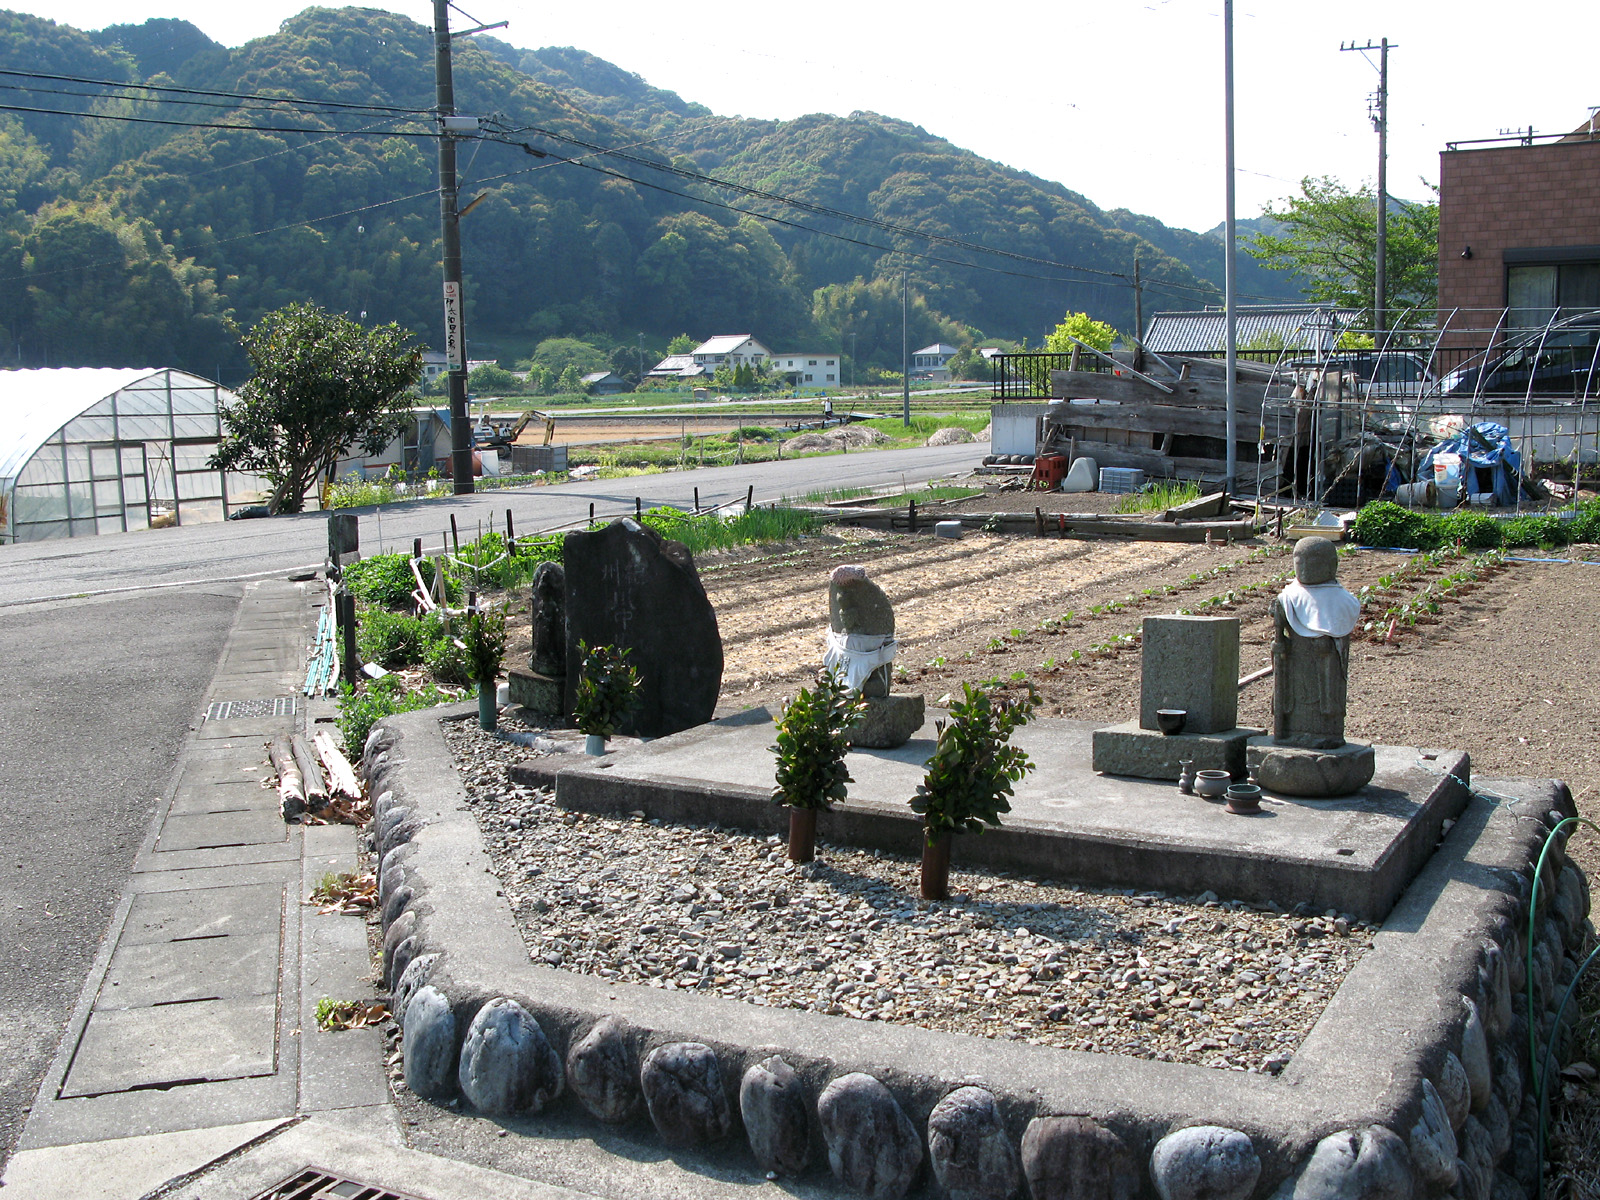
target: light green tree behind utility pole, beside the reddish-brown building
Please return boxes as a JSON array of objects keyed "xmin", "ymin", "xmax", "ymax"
[{"xmin": 1245, "ymin": 176, "xmax": 1438, "ymax": 323}]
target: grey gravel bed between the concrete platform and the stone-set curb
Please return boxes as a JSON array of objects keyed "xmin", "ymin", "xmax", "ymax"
[{"xmin": 445, "ymin": 717, "xmax": 1374, "ymax": 1072}]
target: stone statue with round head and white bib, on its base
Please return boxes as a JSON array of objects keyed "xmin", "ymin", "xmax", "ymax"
[{"xmin": 1245, "ymin": 538, "xmax": 1376, "ymax": 797}]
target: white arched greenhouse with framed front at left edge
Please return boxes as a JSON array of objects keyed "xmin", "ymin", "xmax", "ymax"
[{"xmin": 0, "ymin": 368, "xmax": 267, "ymax": 542}]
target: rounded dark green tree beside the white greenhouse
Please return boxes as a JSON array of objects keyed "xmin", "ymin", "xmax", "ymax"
[{"xmin": 206, "ymin": 302, "xmax": 422, "ymax": 512}]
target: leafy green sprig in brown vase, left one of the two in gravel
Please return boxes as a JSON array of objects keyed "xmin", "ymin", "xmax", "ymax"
[{"xmin": 771, "ymin": 670, "xmax": 867, "ymax": 862}]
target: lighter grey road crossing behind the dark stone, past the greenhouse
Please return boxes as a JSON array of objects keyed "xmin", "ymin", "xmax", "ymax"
[{"xmin": 0, "ymin": 445, "xmax": 986, "ymax": 608}]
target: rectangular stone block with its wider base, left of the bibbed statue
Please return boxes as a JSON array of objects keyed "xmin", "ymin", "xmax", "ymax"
[{"xmin": 1093, "ymin": 614, "xmax": 1261, "ymax": 779}]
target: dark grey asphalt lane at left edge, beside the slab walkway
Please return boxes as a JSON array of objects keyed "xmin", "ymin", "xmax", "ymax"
[{"xmin": 0, "ymin": 588, "xmax": 242, "ymax": 1158}]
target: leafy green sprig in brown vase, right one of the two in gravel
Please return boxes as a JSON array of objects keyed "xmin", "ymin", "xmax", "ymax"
[{"xmin": 910, "ymin": 683, "xmax": 1038, "ymax": 899}]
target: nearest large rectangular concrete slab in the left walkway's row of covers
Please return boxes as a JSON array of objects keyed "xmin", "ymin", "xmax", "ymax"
[{"xmin": 61, "ymin": 994, "xmax": 278, "ymax": 1099}]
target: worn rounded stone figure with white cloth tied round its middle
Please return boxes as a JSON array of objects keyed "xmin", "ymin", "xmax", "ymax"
[{"xmin": 822, "ymin": 566, "xmax": 925, "ymax": 750}]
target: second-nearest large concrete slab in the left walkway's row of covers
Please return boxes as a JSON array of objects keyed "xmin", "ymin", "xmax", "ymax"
[{"xmin": 94, "ymin": 930, "xmax": 278, "ymax": 1010}]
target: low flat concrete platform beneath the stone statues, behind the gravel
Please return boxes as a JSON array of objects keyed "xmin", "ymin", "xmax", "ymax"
[{"xmin": 510, "ymin": 710, "xmax": 1470, "ymax": 920}]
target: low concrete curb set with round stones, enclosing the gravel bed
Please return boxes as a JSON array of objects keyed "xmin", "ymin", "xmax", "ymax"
[{"xmin": 363, "ymin": 706, "xmax": 1592, "ymax": 1200}]
